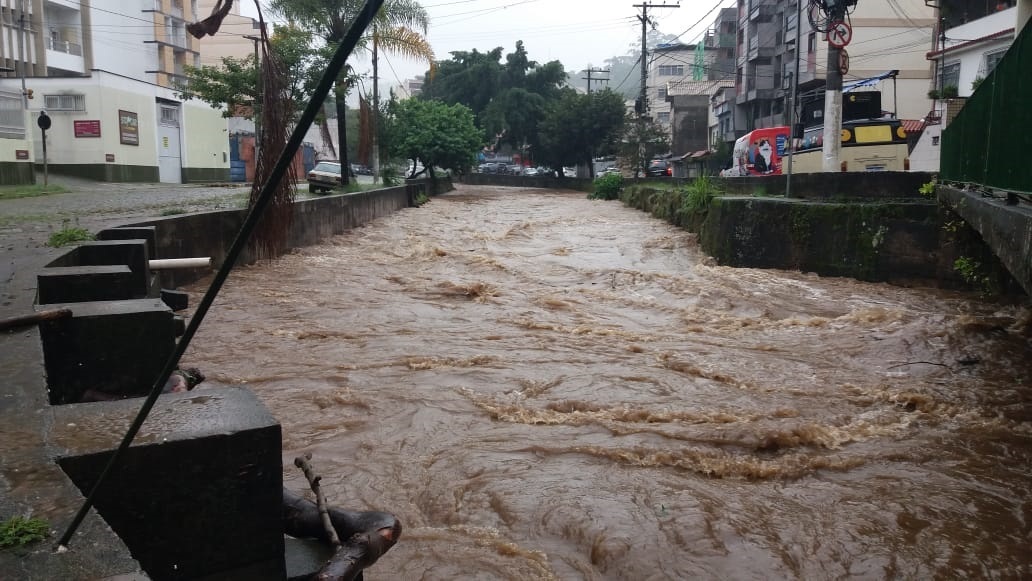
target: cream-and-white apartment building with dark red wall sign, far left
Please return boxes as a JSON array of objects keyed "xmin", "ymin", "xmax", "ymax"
[{"xmin": 0, "ymin": 0, "xmax": 228, "ymax": 183}]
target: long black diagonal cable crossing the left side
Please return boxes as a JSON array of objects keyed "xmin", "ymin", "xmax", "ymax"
[{"xmin": 58, "ymin": 0, "xmax": 385, "ymax": 548}]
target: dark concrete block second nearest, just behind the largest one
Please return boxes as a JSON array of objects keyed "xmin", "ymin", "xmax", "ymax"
[{"xmin": 39, "ymin": 298, "xmax": 175, "ymax": 405}]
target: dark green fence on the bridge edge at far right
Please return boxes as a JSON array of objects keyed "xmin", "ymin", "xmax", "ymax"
[{"xmin": 939, "ymin": 20, "xmax": 1032, "ymax": 192}]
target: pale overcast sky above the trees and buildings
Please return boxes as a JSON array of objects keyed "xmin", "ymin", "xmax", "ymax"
[{"xmin": 240, "ymin": 0, "xmax": 735, "ymax": 93}]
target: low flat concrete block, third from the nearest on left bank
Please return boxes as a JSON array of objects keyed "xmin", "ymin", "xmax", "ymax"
[{"xmin": 36, "ymin": 264, "xmax": 133, "ymax": 304}]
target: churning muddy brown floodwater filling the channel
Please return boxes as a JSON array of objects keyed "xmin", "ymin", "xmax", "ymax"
[{"xmin": 184, "ymin": 187, "xmax": 1032, "ymax": 580}]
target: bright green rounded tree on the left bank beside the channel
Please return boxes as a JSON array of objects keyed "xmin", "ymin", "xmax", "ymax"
[{"xmin": 387, "ymin": 99, "xmax": 483, "ymax": 180}]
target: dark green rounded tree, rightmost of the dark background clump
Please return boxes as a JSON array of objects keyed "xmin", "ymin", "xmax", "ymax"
[{"xmin": 538, "ymin": 89, "xmax": 625, "ymax": 178}]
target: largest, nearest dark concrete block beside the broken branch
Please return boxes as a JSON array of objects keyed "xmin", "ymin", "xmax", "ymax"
[{"xmin": 51, "ymin": 388, "xmax": 286, "ymax": 581}]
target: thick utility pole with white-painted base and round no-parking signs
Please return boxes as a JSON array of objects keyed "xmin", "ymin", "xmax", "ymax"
[{"xmin": 821, "ymin": 0, "xmax": 857, "ymax": 171}]
